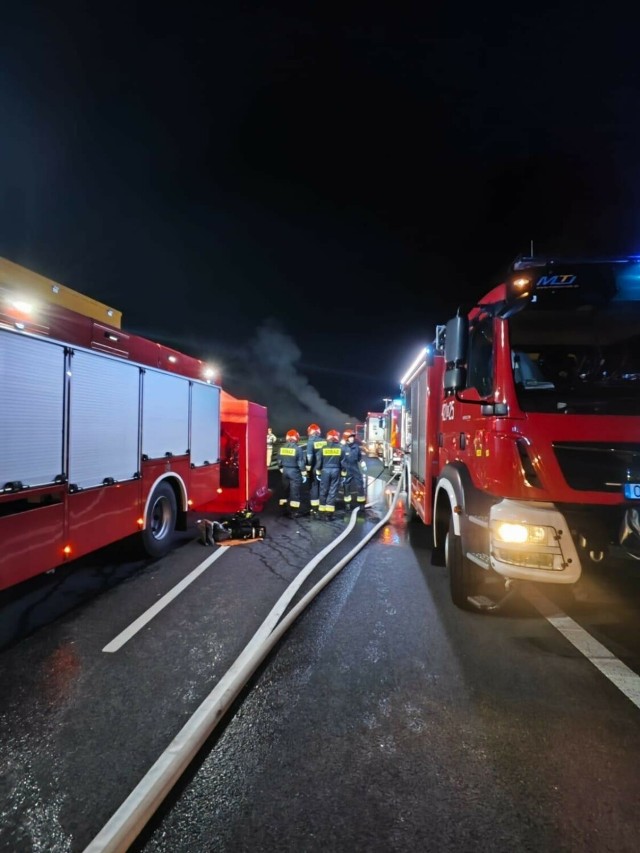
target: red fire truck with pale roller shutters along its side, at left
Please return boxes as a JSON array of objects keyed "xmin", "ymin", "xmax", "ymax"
[{"xmin": 0, "ymin": 259, "xmax": 269, "ymax": 589}]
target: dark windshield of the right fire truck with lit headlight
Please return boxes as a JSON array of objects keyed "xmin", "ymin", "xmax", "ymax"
[{"xmin": 509, "ymin": 301, "xmax": 640, "ymax": 415}]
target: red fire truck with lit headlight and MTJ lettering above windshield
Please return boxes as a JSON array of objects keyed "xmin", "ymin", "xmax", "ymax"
[{"xmin": 401, "ymin": 257, "xmax": 640, "ymax": 610}]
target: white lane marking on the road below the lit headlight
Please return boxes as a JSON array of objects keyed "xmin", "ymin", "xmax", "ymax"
[{"xmin": 525, "ymin": 588, "xmax": 640, "ymax": 708}]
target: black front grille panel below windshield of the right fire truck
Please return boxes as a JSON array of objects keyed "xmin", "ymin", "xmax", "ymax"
[{"xmin": 553, "ymin": 441, "xmax": 640, "ymax": 492}]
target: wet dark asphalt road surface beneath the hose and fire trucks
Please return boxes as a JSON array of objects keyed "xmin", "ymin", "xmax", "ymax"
[{"xmin": 0, "ymin": 463, "xmax": 640, "ymax": 853}]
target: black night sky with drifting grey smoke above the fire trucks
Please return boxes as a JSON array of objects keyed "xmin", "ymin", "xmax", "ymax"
[{"xmin": 0, "ymin": 0, "xmax": 640, "ymax": 433}]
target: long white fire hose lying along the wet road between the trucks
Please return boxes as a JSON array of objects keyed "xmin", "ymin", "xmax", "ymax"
[{"xmin": 84, "ymin": 492, "xmax": 400, "ymax": 853}]
